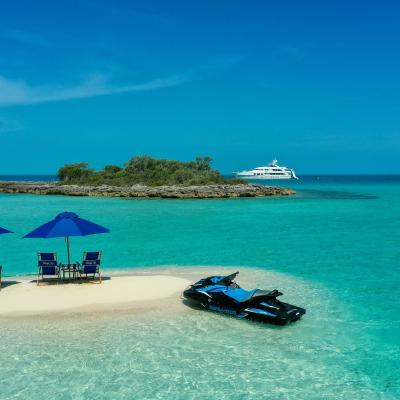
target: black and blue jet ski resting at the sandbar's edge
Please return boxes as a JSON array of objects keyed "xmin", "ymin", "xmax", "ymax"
[{"xmin": 183, "ymin": 272, "xmax": 306, "ymax": 325}]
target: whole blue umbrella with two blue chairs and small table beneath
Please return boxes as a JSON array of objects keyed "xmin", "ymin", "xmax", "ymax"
[{"xmin": 24, "ymin": 211, "xmax": 110, "ymax": 283}]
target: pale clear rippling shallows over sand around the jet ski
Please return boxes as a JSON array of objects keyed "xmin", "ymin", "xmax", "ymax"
[{"xmin": 0, "ymin": 267, "xmax": 391, "ymax": 400}]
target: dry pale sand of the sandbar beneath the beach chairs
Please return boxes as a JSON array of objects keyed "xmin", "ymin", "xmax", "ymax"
[{"xmin": 0, "ymin": 275, "xmax": 190, "ymax": 316}]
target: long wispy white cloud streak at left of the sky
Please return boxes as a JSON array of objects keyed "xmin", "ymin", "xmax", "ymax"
[{"xmin": 0, "ymin": 74, "xmax": 190, "ymax": 107}]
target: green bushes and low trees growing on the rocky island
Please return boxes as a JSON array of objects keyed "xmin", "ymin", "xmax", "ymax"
[{"xmin": 58, "ymin": 156, "xmax": 245, "ymax": 186}]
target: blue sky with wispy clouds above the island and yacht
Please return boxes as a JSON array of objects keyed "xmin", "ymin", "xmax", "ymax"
[{"xmin": 0, "ymin": 0, "xmax": 400, "ymax": 175}]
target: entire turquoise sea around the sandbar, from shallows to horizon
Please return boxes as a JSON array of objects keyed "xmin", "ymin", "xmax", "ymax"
[{"xmin": 0, "ymin": 177, "xmax": 400, "ymax": 399}]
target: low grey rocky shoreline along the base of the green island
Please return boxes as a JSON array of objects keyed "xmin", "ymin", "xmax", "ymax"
[{"xmin": 0, "ymin": 182, "xmax": 295, "ymax": 199}]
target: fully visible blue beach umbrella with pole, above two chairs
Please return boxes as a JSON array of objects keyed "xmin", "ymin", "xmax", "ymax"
[{"xmin": 24, "ymin": 212, "xmax": 110, "ymax": 265}]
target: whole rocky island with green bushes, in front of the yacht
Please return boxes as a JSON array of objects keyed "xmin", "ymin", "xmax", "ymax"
[{"xmin": 0, "ymin": 156, "xmax": 295, "ymax": 199}]
